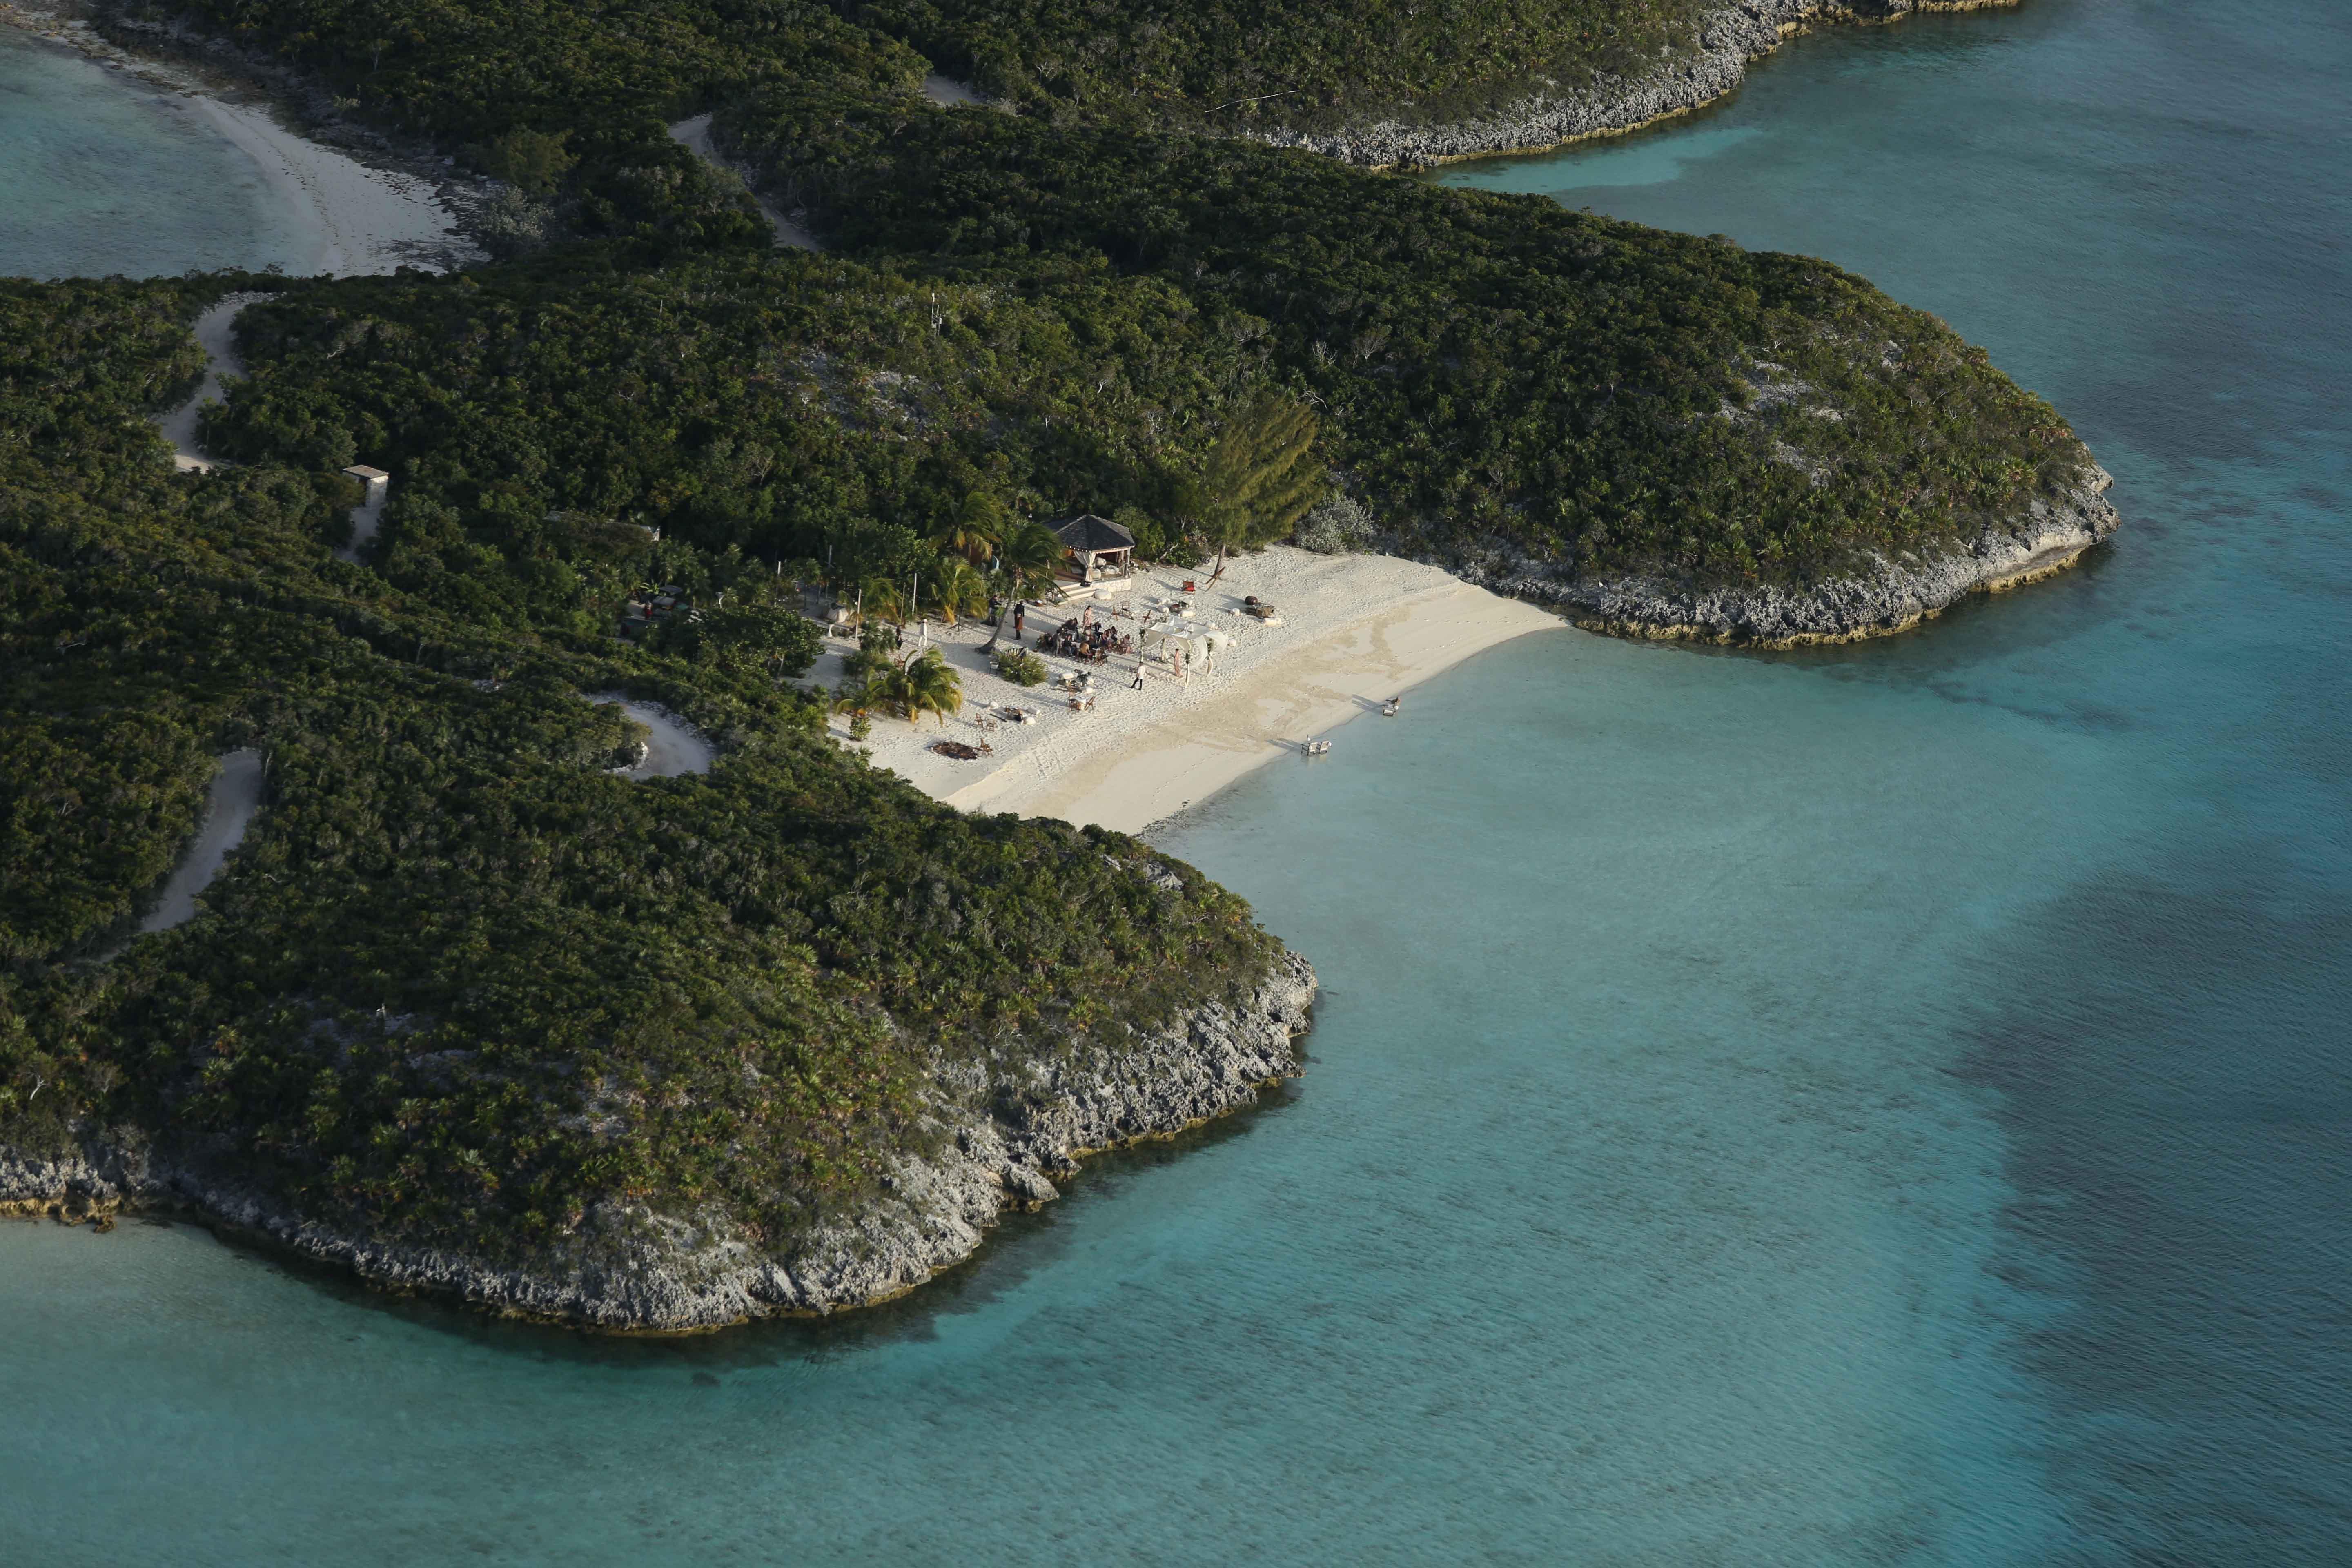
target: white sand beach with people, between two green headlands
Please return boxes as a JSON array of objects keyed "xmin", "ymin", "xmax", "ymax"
[{"xmin": 809, "ymin": 546, "xmax": 1566, "ymax": 832}]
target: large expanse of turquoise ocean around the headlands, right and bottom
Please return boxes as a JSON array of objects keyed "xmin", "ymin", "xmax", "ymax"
[{"xmin": 0, "ymin": 0, "xmax": 2352, "ymax": 1566}]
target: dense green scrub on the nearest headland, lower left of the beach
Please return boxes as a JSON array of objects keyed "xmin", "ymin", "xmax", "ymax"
[{"xmin": 0, "ymin": 285, "xmax": 1272, "ymax": 1248}]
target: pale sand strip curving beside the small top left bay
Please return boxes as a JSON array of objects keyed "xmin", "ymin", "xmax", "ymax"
[{"xmin": 195, "ymin": 94, "xmax": 480, "ymax": 277}]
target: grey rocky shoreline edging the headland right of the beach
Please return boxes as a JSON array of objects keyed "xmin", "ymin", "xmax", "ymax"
[{"xmin": 1439, "ymin": 466, "xmax": 2122, "ymax": 649}]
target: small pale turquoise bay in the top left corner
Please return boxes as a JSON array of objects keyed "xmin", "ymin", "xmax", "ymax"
[{"xmin": 0, "ymin": 26, "xmax": 310, "ymax": 277}]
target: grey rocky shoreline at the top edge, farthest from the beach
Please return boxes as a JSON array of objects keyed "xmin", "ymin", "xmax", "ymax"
[{"xmin": 1249, "ymin": 0, "xmax": 2020, "ymax": 169}]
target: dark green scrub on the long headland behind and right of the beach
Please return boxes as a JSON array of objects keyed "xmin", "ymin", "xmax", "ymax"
[{"xmin": 739, "ymin": 99, "xmax": 2086, "ymax": 581}]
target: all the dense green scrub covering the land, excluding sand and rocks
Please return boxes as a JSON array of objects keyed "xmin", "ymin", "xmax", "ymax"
[{"xmin": 0, "ymin": 0, "xmax": 2086, "ymax": 1288}]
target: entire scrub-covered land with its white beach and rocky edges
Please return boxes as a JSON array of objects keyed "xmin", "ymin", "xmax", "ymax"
[{"xmin": 0, "ymin": 0, "xmax": 2114, "ymax": 1331}]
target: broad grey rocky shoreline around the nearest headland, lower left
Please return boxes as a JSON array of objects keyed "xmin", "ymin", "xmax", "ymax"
[{"xmin": 0, "ymin": 954, "xmax": 1315, "ymax": 1333}]
